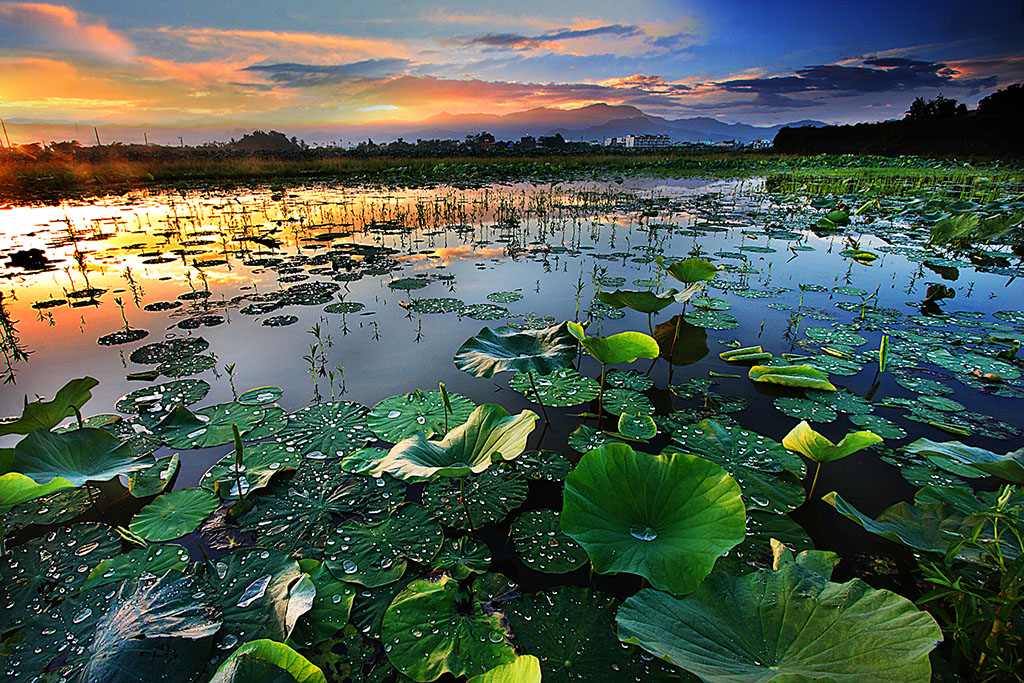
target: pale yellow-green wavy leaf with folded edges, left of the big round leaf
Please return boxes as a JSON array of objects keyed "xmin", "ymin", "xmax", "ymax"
[{"xmin": 374, "ymin": 403, "xmax": 537, "ymax": 480}]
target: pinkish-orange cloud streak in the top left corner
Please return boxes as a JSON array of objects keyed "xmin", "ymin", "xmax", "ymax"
[{"xmin": 0, "ymin": 2, "xmax": 135, "ymax": 61}]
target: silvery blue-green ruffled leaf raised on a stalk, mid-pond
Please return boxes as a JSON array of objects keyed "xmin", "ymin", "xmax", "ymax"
[{"xmin": 455, "ymin": 324, "xmax": 577, "ymax": 377}]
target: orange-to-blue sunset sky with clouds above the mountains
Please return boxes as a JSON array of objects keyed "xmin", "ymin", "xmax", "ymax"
[{"xmin": 0, "ymin": 0, "xmax": 1024, "ymax": 139}]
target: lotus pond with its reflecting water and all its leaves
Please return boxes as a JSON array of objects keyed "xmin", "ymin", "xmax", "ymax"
[{"xmin": 0, "ymin": 165, "xmax": 1024, "ymax": 683}]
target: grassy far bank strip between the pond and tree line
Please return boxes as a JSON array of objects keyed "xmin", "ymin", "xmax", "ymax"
[{"xmin": 0, "ymin": 147, "xmax": 1024, "ymax": 202}]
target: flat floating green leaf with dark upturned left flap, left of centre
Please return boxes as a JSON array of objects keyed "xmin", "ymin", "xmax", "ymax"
[{"xmin": 157, "ymin": 402, "xmax": 266, "ymax": 449}]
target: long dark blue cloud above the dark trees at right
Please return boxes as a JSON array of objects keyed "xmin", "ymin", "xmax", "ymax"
[{"xmin": 715, "ymin": 57, "xmax": 996, "ymax": 106}]
